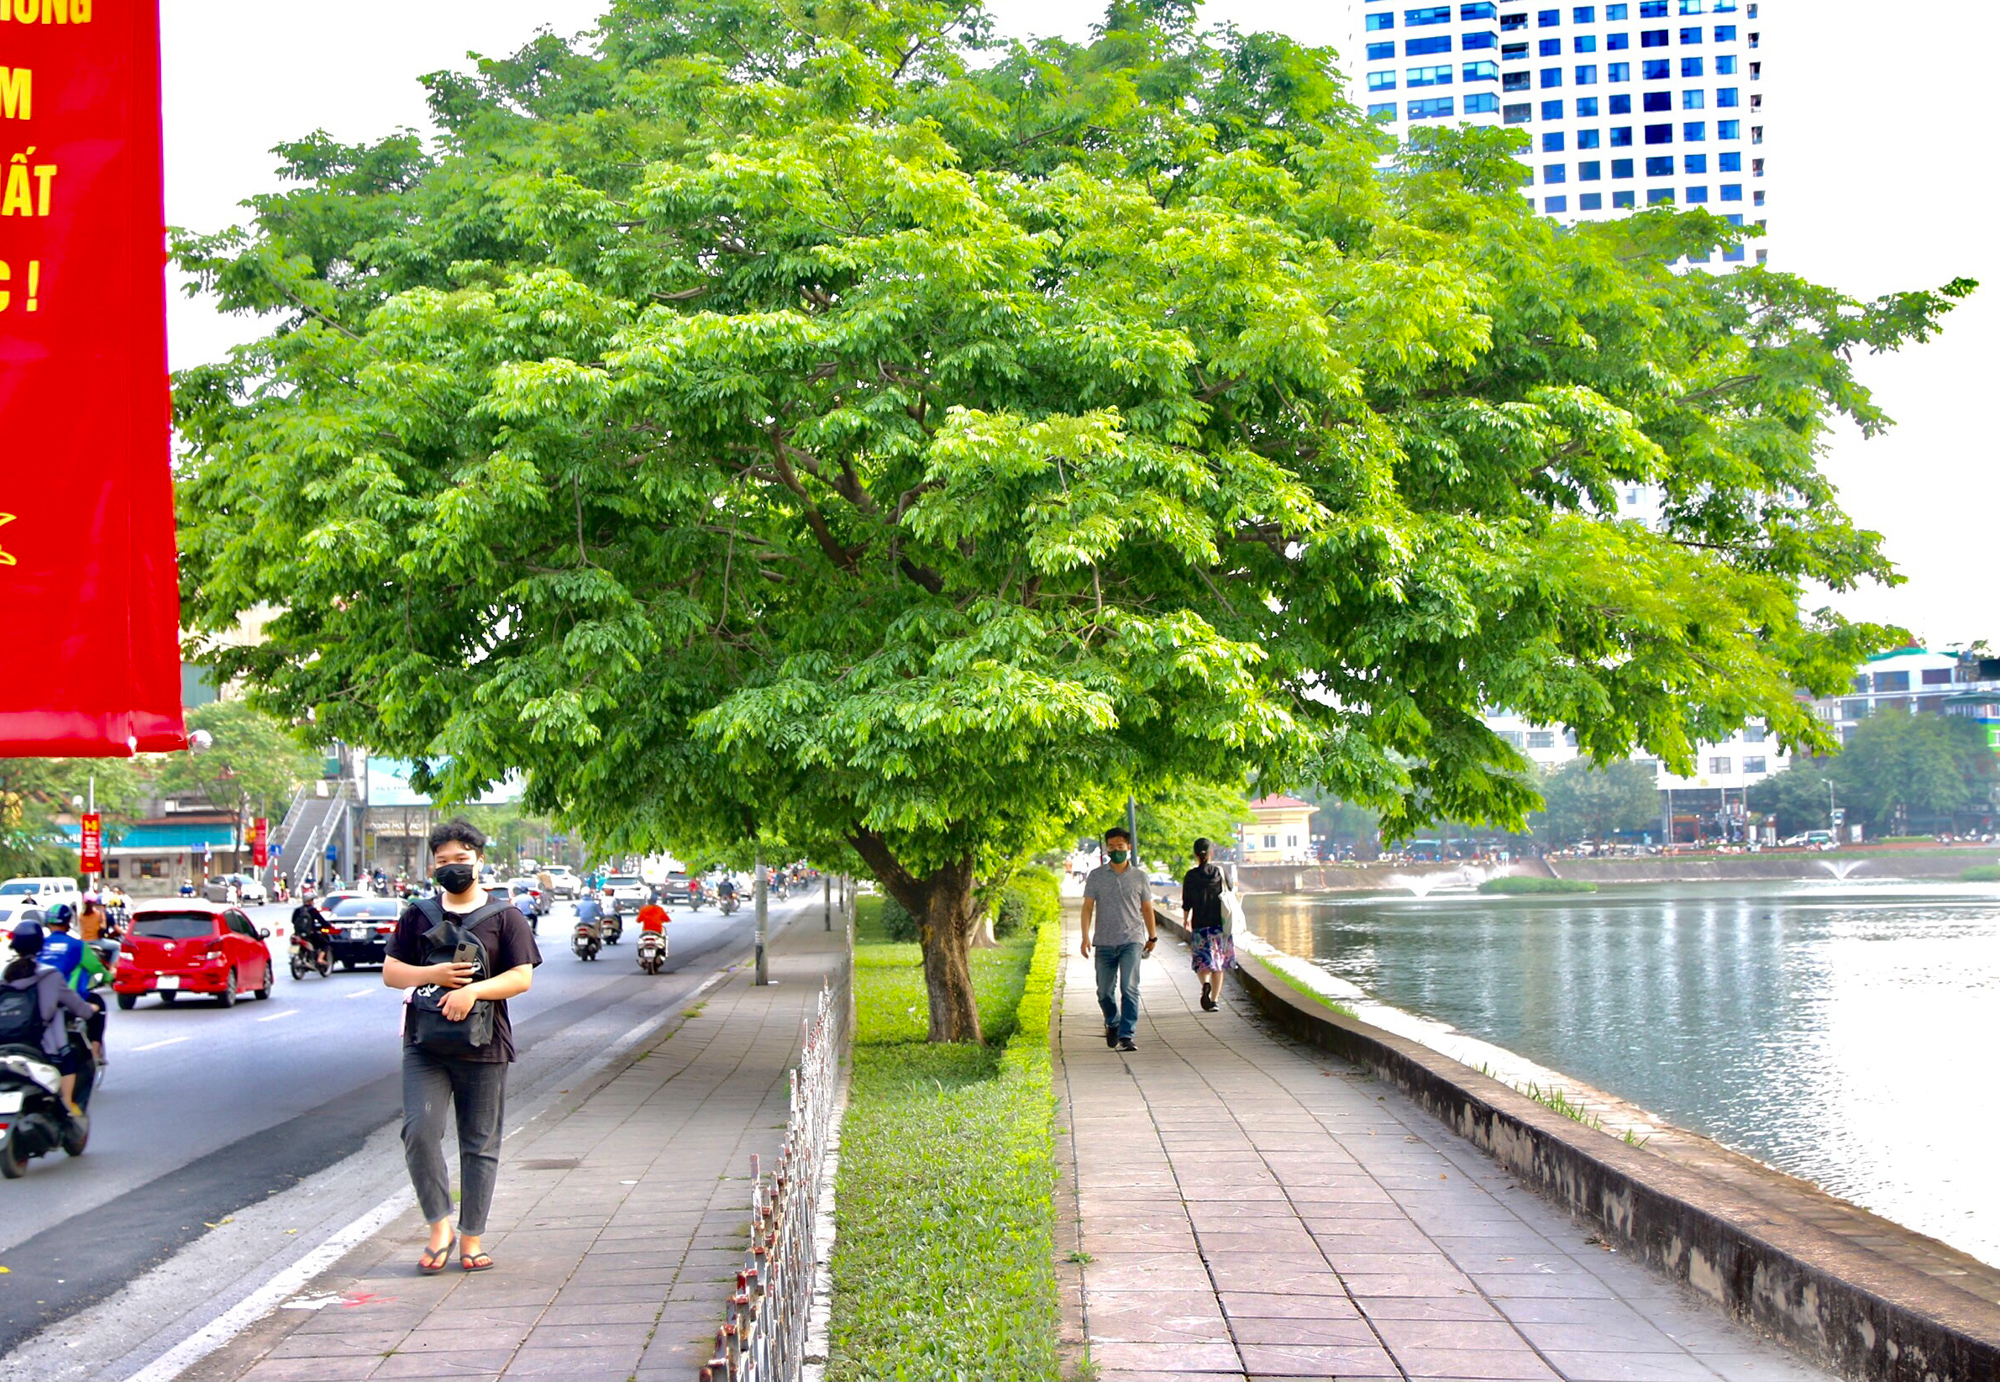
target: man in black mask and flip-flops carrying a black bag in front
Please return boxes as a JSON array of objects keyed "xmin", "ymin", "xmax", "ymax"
[{"xmin": 382, "ymin": 820, "xmax": 542, "ymax": 1276}]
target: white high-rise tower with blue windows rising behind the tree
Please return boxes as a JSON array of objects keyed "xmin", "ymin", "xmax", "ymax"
[{"xmin": 1342, "ymin": 0, "xmax": 1766, "ymax": 264}]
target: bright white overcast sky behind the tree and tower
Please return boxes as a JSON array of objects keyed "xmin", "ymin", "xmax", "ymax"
[{"xmin": 162, "ymin": 0, "xmax": 2000, "ymax": 646}]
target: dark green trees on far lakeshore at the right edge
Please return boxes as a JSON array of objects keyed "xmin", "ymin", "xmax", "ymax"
[{"xmin": 1828, "ymin": 714, "xmax": 1996, "ymax": 834}]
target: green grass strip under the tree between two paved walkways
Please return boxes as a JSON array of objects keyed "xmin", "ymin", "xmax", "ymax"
[{"xmin": 828, "ymin": 898, "xmax": 1062, "ymax": 1382}]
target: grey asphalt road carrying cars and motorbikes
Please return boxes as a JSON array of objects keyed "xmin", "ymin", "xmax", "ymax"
[{"xmin": 0, "ymin": 894, "xmax": 796, "ymax": 1356}]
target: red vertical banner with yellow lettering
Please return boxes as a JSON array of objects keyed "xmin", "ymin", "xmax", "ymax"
[{"xmin": 0, "ymin": 0, "xmax": 186, "ymax": 756}]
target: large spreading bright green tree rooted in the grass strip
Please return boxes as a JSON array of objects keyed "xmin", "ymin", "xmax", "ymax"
[{"xmin": 178, "ymin": 0, "xmax": 1964, "ymax": 1040}]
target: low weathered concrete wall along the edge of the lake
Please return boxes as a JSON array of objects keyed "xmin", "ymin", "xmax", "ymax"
[{"xmin": 1200, "ymin": 916, "xmax": 2000, "ymax": 1382}]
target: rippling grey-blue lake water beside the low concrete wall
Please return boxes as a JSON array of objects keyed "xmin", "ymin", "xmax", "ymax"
[{"xmin": 1244, "ymin": 878, "xmax": 2000, "ymax": 1264}]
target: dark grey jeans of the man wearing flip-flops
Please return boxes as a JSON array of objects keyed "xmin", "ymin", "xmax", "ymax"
[{"xmin": 402, "ymin": 1046, "xmax": 506, "ymax": 1234}]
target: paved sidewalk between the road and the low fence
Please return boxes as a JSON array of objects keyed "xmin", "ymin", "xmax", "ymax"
[{"xmin": 182, "ymin": 912, "xmax": 846, "ymax": 1382}]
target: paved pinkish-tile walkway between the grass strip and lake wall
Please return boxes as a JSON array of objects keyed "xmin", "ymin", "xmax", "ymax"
[{"xmin": 1056, "ymin": 914, "xmax": 1830, "ymax": 1382}]
